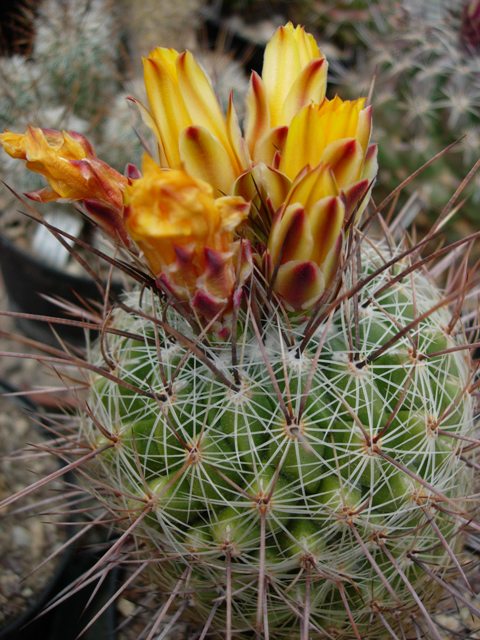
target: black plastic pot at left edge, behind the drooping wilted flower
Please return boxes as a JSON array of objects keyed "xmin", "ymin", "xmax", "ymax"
[{"xmin": 0, "ymin": 235, "xmax": 122, "ymax": 346}]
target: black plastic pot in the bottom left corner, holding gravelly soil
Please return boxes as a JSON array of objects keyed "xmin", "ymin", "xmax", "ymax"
[{"xmin": 0, "ymin": 380, "xmax": 119, "ymax": 640}]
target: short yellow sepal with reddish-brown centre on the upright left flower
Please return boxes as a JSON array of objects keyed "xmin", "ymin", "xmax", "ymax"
[{"xmin": 179, "ymin": 127, "xmax": 236, "ymax": 195}]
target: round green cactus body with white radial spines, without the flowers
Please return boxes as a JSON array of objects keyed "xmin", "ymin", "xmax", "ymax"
[{"xmin": 82, "ymin": 245, "xmax": 474, "ymax": 639}]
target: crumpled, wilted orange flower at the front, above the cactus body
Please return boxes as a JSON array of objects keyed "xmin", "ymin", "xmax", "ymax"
[{"xmin": 126, "ymin": 156, "xmax": 249, "ymax": 317}]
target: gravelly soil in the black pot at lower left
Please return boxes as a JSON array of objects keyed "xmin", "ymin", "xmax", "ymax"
[{"xmin": 0, "ymin": 396, "xmax": 66, "ymax": 632}]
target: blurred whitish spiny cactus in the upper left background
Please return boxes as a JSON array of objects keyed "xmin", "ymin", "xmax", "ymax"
[{"xmin": 0, "ymin": 0, "xmax": 140, "ymax": 200}]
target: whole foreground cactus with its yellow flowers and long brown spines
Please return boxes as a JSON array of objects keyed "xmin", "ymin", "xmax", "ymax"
[{"xmin": 0, "ymin": 24, "xmax": 479, "ymax": 640}]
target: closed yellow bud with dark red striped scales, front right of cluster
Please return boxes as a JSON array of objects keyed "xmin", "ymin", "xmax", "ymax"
[{"xmin": 268, "ymin": 164, "xmax": 345, "ymax": 310}]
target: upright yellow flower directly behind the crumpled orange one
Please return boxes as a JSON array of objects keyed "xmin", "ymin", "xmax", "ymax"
[{"xmin": 143, "ymin": 48, "xmax": 249, "ymax": 195}]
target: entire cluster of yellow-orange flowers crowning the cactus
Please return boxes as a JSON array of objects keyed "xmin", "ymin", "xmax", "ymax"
[{"xmin": 0, "ymin": 23, "xmax": 377, "ymax": 318}]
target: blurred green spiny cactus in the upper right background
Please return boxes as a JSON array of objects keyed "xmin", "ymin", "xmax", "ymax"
[{"xmin": 341, "ymin": 0, "xmax": 480, "ymax": 236}]
